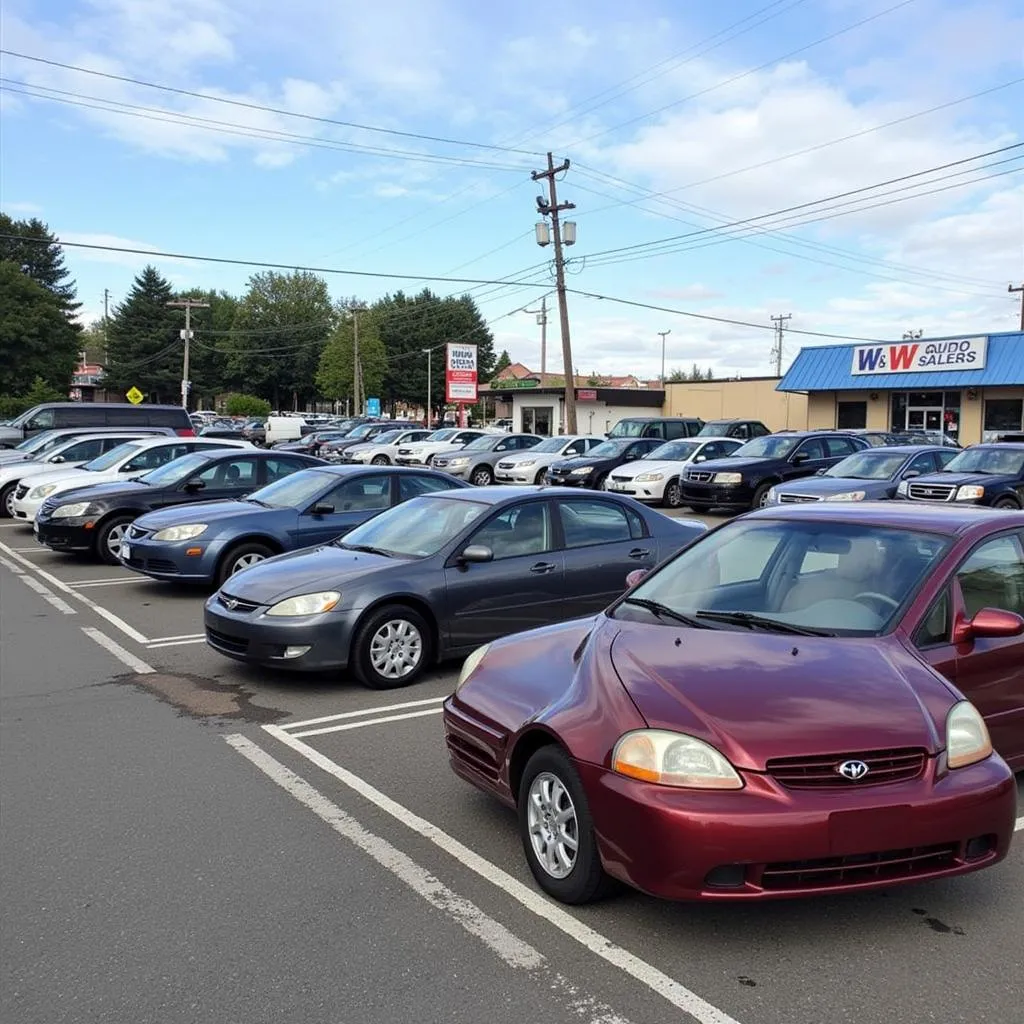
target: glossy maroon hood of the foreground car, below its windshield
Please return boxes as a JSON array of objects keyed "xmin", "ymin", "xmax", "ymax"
[{"xmin": 608, "ymin": 621, "xmax": 956, "ymax": 770}]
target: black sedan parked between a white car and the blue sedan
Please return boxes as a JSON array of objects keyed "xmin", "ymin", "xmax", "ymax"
[{"xmin": 35, "ymin": 449, "xmax": 324, "ymax": 565}]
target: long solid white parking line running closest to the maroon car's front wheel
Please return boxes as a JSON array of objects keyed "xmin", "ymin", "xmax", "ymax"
[{"xmin": 263, "ymin": 725, "xmax": 737, "ymax": 1024}]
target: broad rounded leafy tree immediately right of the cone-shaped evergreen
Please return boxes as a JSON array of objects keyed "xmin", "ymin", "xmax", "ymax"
[{"xmin": 227, "ymin": 270, "xmax": 337, "ymax": 409}]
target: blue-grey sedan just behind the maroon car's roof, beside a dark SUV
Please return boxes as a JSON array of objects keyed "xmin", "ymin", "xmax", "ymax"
[{"xmin": 765, "ymin": 444, "xmax": 957, "ymax": 505}]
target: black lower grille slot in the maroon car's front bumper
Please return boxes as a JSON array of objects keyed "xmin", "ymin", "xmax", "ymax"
[{"xmin": 761, "ymin": 843, "xmax": 957, "ymax": 889}]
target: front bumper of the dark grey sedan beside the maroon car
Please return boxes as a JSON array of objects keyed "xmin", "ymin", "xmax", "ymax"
[{"xmin": 203, "ymin": 594, "xmax": 359, "ymax": 672}]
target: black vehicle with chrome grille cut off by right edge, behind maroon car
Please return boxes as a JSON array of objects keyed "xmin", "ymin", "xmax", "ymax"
[{"xmin": 896, "ymin": 441, "xmax": 1024, "ymax": 509}]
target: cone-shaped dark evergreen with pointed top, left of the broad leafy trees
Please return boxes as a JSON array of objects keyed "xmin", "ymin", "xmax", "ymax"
[{"xmin": 103, "ymin": 266, "xmax": 183, "ymax": 402}]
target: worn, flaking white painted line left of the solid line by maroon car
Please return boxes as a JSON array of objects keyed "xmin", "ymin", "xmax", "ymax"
[{"xmin": 224, "ymin": 733, "xmax": 629, "ymax": 1024}]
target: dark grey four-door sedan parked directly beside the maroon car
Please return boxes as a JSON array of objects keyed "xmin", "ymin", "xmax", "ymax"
[{"xmin": 205, "ymin": 486, "xmax": 705, "ymax": 689}]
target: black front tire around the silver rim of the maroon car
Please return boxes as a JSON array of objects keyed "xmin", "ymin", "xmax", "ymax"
[{"xmin": 518, "ymin": 745, "xmax": 613, "ymax": 905}]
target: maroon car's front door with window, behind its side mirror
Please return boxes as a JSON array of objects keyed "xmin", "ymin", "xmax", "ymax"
[{"xmin": 914, "ymin": 530, "xmax": 1024, "ymax": 768}]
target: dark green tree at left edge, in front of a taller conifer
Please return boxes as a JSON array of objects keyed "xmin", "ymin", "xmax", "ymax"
[{"xmin": 0, "ymin": 261, "xmax": 79, "ymax": 398}]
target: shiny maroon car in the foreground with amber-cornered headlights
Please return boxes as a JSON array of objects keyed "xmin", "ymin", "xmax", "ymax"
[{"xmin": 444, "ymin": 503, "xmax": 1024, "ymax": 903}]
